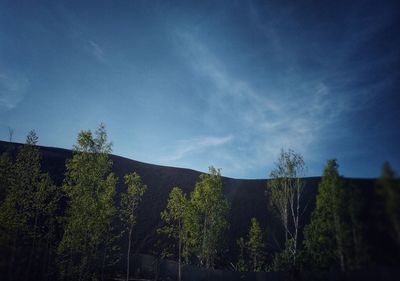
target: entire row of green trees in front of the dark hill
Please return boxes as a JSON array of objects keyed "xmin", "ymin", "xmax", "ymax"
[{"xmin": 0, "ymin": 125, "xmax": 400, "ymax": 280}]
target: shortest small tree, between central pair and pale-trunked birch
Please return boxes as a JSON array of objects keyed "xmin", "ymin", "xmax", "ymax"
[{"xmin": 246, "ymin": 218, "xmax": 264, "ymax": 271}]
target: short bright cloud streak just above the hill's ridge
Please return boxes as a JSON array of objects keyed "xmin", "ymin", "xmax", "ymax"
[{"xmin": 165, "ymin": 136, "xmax": 232, "ymax": 162}]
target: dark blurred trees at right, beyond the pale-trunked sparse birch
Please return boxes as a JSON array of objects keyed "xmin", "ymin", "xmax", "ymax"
[{"xmin": 302, "ymin": 160, "xmax": 400, "ymax": 271}]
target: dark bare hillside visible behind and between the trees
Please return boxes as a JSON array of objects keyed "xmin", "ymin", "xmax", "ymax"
[{"xmin": 0, "ymin": 141, "xmax": 374, "ymax": 262}]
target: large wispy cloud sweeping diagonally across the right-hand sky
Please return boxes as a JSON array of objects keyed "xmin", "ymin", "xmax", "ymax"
[{"xmin": 173, "ymin": 32, "xmax": 349, "ymax": 174}]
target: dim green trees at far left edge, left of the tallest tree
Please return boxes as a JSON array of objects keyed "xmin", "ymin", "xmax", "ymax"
[{"xmin": 0, "ymin": 131, "xmax": 60, "ymax": 278}]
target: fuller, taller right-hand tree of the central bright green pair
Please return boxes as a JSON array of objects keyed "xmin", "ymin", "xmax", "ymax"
[{"xmin": 187, "ymin": 167, "xmax": 229, "ymax": 268}]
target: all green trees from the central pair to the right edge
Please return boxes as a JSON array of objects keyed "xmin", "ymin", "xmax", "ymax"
[{"xmin": 160, "ymin": 150, "xmax": 400, "ymax": 280}]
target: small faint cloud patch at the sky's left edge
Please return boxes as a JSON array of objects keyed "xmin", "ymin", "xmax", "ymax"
[{"xmin": 0, "ymin": 71, "xmax": 30, "ymax": 109}]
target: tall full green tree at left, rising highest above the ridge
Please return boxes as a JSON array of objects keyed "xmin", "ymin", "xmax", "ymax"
[{"xmin": 58, "ymin": 125, "xmax": 117, "ymax": 280}]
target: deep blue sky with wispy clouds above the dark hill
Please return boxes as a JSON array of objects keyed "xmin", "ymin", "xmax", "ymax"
[{"xmin": 0, "ymin": 0, "xmax": 400, "ymax": 178}]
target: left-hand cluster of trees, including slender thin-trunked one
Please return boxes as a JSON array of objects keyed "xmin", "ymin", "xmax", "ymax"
[{"xmin": 0, "ymin": 125, "xmax": 146, "ymax": 280}]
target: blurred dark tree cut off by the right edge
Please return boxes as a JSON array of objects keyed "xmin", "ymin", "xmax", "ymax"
[{"xmin": 377, "ymin": 162, "xmax": 400, "ymax": 247}]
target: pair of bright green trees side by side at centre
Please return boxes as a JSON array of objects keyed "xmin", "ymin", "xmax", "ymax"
[{"xmin": 159, "ymin": 167, "xmax": 230, "ymax": 280}]
